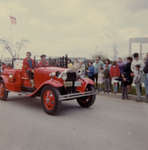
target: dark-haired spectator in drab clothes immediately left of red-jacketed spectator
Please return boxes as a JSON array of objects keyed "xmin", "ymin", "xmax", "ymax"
[{"xmin": 104, "ymin": 63, "xmax": 111, "ymax": 94}]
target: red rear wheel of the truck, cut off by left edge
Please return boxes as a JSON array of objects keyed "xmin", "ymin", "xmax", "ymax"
[{"xmin": 0, "ymin": 80, "xmax": 8, "ymax": 100}]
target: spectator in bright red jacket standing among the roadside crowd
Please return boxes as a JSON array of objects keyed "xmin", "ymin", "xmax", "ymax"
[{"xmin": 110, "ymin": 61, "xmax": 120, "ymax": 94}]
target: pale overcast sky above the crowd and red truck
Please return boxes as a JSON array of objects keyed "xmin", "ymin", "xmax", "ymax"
[{"xmin": 0, "ymin": 0, "xmax": 148, "ymax": 57}]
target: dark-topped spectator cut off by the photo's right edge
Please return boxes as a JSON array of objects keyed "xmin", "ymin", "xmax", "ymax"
[{"xmin": 143, "ymin": 53, "xmax": 148, "ymax": 102}]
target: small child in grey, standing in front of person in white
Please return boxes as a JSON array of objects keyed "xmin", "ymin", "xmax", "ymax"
[{"xmin": 134, "ymin": 64, "xmax": 142, "ymax": 101}]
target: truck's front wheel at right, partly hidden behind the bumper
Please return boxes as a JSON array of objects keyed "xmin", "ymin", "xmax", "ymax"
[{"xmin": 77, "ymin": 85, "xmax": 96, "ymax": 108}]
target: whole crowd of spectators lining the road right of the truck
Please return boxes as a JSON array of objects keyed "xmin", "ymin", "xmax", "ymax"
[{"xmin": 68, "ymin": 53, "xmax": 148, "ymax": 102}]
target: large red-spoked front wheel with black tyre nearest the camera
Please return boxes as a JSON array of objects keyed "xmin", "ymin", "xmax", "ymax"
[{"xmin": 41, "ymin": 86, "xmax": 60, "ymax": 115}]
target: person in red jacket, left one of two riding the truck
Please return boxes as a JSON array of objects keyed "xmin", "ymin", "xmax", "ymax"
[{"xmin": 23, "ymin": 52, "xmax": 35, "ymax": 87}]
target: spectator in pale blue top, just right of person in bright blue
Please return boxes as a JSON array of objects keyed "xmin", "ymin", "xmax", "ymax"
[{"xmin": 93, "ymin": 57, "xmax": 103, "ymax": 87}]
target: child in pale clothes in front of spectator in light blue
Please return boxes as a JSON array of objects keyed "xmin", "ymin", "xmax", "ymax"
[{"xmin": 98, "ymin": 67, "xmax": 104, "ymax": 91}]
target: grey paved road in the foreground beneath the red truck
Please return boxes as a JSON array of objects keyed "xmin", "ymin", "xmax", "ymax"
[{"xmin": 0, "ymin": 95, "xmax": 148, "ymax": 150}]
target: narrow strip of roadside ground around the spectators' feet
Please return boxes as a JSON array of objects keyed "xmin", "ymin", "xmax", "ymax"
[{"xmin": 98, "ymin": 92, "xmax": 148, "ymax": 103}]
